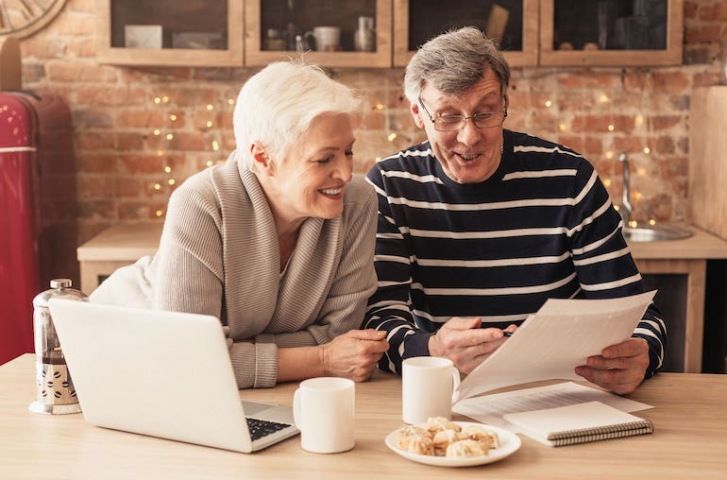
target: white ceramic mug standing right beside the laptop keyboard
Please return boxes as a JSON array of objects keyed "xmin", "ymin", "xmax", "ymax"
[{"xmin": 293, "ymin": 377, "xmax": 356, "ymax": 453}]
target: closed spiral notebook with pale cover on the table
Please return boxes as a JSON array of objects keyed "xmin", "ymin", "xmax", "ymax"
[{"xmin": 503, "ymin": 402, "xmax": 654, "ymax": 447}]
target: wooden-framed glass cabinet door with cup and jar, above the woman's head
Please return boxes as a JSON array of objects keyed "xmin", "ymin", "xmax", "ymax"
[{"xmin": 245, "ymin": 0, "xmax": 392, "ymax": 68}]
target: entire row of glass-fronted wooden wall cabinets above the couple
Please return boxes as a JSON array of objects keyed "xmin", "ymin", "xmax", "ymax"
[{"xmin": 96, "ymin": 0, "xmax": 684, "ymax": 68}]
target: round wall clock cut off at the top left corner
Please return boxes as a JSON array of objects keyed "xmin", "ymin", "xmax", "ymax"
[{"xmin": 0, "ymin": 0, "xmax": 68, "ymax": 38}]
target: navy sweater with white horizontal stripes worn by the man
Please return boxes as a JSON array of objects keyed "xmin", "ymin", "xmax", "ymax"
[{"xmin": 364, "ymin": 130, "xmax": 666, "ymax": 376}]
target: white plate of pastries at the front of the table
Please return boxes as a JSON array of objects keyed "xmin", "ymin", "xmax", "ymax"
[{"xmin": 385, "ymin": 417, "xmax": 521, "ymax": 467}]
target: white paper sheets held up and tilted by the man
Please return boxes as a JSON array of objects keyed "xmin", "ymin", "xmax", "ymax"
[{"xmin": 457, "ymin": 291, "xmax": 656, "ymax": 400}]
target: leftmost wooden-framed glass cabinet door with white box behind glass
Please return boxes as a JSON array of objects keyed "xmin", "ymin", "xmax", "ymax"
[{"xmin": 96, "ymin": 0, "xmax": 243, "ymax": 67}]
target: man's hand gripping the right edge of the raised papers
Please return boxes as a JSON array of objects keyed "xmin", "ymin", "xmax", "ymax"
[{"xmin": 576, "ymin": 338, "xmax": 649, "ymax": 395}]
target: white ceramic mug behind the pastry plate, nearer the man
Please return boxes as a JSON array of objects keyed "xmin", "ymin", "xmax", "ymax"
[{"xmin": 401, "ymin": 357, "xmax": 460, "ymax": 424}]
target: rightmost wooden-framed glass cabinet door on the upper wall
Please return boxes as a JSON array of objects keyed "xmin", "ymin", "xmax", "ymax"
[{"xmin": 540, "ymin": 0, "xmax": 683, "ymax": 66}]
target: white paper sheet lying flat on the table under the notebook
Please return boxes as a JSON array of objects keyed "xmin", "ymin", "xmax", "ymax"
[{"xmin": 452, "ymin": 382, "xmax": 652, "ymax": 432}]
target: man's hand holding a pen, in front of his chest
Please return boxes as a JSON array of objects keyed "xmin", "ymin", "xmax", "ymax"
[{"xmin": 429, "ymin": 317, "xmax": 516, "ymax": 373}]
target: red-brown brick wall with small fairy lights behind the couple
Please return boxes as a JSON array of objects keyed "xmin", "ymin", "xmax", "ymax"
[{"xmin": 15, "ymin": 0, "xmax": 727, "ymax": 242}]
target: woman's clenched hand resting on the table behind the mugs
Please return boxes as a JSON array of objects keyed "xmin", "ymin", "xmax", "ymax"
[{"xmin": 320, "ymin": 329, "xmax": 389, "ymax": 382}]
